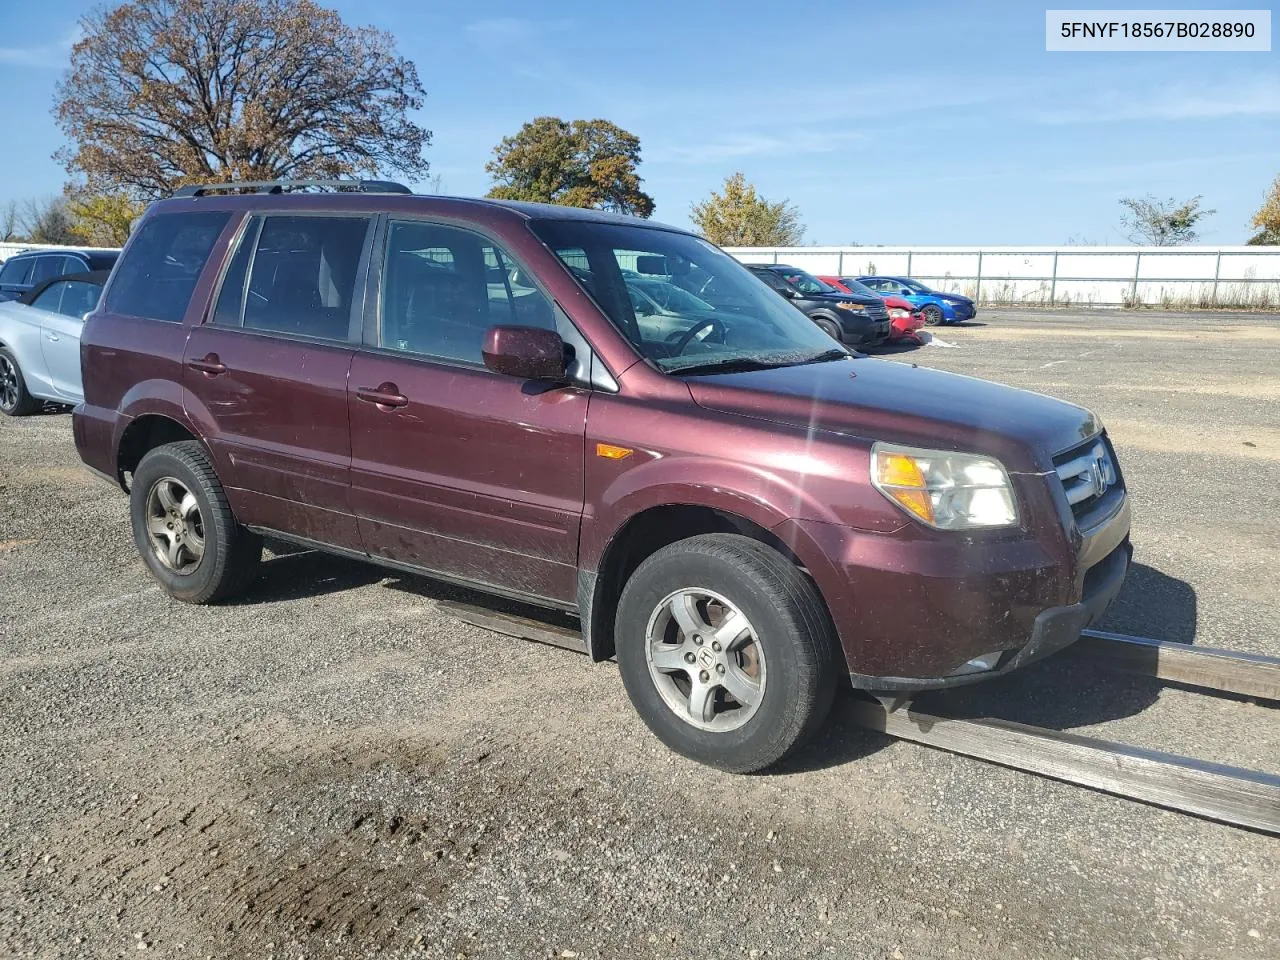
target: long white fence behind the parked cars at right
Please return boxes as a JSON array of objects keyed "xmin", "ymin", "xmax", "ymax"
[{"xmin": 728, "ymin": 247, "xmax": 1280, "ymax": 307}]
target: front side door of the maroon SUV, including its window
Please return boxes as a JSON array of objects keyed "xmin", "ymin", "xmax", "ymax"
[{"xmin": 348, "ymin": 221, "xmax": 589, "ymax": 603}]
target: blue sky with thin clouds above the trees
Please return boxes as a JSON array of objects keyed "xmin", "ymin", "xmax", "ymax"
[{"xmin": 0, "ymin": 0, "xmax": 1280, "ymax": 244}]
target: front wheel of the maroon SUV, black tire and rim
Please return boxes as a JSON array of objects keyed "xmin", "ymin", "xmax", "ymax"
[{"xmin": 614, "ymin": 534, "xmax": 836, "ymax": 773}]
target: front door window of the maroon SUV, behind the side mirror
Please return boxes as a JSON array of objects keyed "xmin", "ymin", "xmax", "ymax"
[{"xmin": 381, "ymin": 223, "xmax": 556, "ymax": 364}]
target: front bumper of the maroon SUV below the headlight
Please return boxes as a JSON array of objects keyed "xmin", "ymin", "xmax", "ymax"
[{"xmin": 774, "ymin": 488, "xmax": 1132, "ymax": 690}]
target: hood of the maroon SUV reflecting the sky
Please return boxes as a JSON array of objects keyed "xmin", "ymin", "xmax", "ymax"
[{"xmin": 686, "ymin": 357, "xmax": 1102, "ymax": 471}]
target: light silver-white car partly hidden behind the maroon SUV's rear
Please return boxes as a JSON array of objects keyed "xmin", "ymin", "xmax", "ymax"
[{"xmin": 0, "ymin": 270, "xmax": 109, "ymax": 416}]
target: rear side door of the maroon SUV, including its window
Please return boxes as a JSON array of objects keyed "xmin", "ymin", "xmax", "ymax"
[{"xmin": 183, "ymin": 214, "xmax": 372, "ymax": 549}]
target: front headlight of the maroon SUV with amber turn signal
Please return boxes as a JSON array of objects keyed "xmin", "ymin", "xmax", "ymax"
[{"xmin": 872, "ymin": 443, "xmax": 1018, "ymax": 530}]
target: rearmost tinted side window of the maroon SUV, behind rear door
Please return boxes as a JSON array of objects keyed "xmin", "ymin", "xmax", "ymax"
[{"xmin": 106, "ymin": 210, "xmax": 230, "ymax": 324}]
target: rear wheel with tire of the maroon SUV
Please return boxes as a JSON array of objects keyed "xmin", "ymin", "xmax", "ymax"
[{"xmin": 129, "ymin": 440, "xmax": 262, "ymax": 603}]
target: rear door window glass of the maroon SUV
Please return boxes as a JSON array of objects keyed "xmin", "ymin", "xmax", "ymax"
[{"xmin": 238, "ymin": 216, "xmax": 370, "ymax": 340}]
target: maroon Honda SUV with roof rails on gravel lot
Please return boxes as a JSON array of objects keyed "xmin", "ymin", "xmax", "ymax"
[{"xmin": 74, "ymin": 184, "xmax": 1130, "ymax": 771}]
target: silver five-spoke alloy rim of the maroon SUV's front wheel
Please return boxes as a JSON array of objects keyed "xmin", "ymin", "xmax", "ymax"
[{"xmin": 645, "ymin": 588, "xmax": 765, "ymax": 732}]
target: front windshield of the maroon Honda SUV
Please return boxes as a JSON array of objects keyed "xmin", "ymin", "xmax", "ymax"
[{"xmin": 530, "ymin": 220, "xmax": 847, "ymax": 374}]
